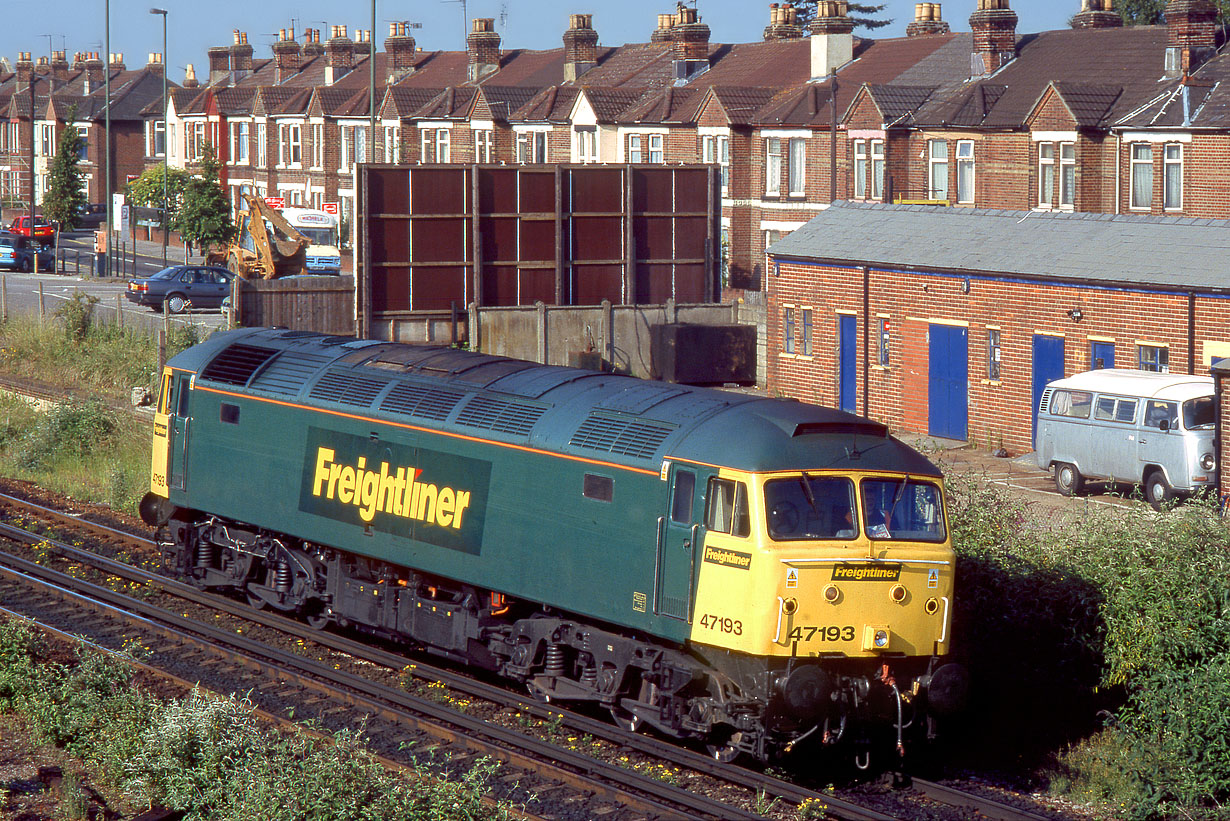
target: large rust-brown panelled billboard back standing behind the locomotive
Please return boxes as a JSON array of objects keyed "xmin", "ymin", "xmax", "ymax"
[{"xmin": 357, "ymin": 165, "xmax": 721, "ymax": 334}]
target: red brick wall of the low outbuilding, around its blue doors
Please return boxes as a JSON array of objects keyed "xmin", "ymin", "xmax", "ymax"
[{"xmin": 766, "ymin": 261, "xmax": 1230, "ymax": 453}]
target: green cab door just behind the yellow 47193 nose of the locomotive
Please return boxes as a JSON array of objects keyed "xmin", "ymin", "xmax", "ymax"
[{"xmin": 653, "ymin": 464, "xmax": 705, "ymax": 623}]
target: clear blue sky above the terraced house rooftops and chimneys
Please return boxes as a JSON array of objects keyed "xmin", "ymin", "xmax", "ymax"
[{"xmin": 0, "ymin": 0, "xmax": 1080, "ymax": 81}]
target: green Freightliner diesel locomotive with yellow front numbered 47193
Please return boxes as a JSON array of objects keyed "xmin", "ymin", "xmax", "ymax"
[{"xmin": 141, "ymin": 329, "xmax": 966, "ymax": 759}]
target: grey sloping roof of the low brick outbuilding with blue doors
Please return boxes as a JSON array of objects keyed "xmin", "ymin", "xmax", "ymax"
[{"xmin": 769, "ymin": 202, "xmax": 1230, "ymax": 292}]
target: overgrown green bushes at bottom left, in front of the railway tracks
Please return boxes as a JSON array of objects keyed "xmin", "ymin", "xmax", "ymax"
[{"xmin": 0, "ymin": 620, "xmax": 512, "ymax": 821}]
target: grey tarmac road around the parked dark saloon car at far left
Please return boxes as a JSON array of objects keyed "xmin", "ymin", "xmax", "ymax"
[{"xmin": 0, "ymin": 231, "xmax": 226, "ymax": 331}]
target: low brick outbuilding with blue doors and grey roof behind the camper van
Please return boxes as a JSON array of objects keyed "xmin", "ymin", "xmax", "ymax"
[{"xmin": 768, "ymin": 202, "xmax": 1230, "ymax": 453}]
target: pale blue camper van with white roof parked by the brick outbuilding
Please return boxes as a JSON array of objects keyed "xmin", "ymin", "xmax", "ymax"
[{"xmin": 1036, "ymin": 368, "xmax": 1218, "ymax": 507}]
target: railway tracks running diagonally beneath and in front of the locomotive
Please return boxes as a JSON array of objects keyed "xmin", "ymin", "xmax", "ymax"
[{"xmin": 0, "ymin": 495, "xmax": 1055, "ymax": 821}]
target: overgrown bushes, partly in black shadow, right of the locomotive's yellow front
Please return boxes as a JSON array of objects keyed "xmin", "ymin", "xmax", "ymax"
[{"xmin": 950, "ymin": 479, "xmax": 1230, "ymax": 819}]
